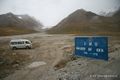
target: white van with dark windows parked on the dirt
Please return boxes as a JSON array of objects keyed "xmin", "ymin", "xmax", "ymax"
[{"xmin": 10, "ymin": 39, "xmax": 32, "ymax": 49}]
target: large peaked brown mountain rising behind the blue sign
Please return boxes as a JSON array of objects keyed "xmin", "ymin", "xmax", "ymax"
[{"xmin": 47, "ymin": 9, "xmax": 120, "ymax": 35}]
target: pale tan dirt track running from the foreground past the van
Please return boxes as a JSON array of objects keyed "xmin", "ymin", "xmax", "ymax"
[{"xmin": 0, "ymin": 33, "xmax": 73, "ymax": 80}]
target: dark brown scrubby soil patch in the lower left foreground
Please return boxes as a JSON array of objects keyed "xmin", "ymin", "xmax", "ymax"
[{"xmin": 0, "ymin": 48, "xmax": 29, "ymax": 80}]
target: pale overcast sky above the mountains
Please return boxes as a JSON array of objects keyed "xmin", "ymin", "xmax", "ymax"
[{"xmin": 0, "ymin": 0, "xmax": 120, "ymax": 27}]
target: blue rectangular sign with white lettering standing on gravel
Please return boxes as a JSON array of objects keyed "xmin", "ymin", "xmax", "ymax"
[{"xmin": 75, "ymin": 37, "xmax": 108, "ymax": 60}]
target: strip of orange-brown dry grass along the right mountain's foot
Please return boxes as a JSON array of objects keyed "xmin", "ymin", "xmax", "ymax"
[{"xmin": 48, "ymin": 28, "xmax": 120, "ymax": 36}]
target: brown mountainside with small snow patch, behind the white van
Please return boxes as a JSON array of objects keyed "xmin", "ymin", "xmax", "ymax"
[{"xmin": 0, "ymin": 13, "xmax": 43, "ymax": 36}]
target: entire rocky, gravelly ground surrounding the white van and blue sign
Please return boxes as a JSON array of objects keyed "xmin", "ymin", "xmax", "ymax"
[{"xmin": 0, "ymin": 33, "xmax": 120, "ymax": 80}]
